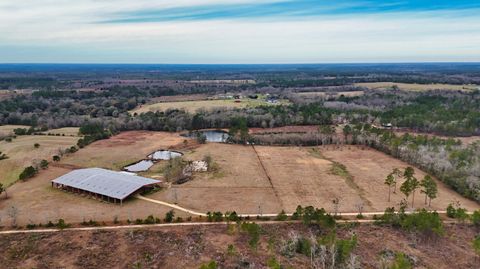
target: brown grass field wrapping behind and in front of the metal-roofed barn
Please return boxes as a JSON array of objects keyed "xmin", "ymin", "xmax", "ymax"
[{"xmin": 0, "ymin": 131, "xmax": 189, "ymax": 225}]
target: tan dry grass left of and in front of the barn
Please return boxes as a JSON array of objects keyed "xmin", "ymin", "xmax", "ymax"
[{"xmin": 0, "ymin": 166, "xmax": 184, "ymax": 226}]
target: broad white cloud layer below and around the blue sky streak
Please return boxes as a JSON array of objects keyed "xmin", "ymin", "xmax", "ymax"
[{"xmin": 0, "ymin": 0, "xmax": 480, "ymax": 63}]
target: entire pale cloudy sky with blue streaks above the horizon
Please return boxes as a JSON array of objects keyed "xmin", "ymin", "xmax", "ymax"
[{"xmin": 0, "ymin": 0, "xmax": 480, "ymax": 64}]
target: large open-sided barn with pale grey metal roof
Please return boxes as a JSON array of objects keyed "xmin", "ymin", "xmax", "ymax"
[{"xmin": 52, "ymin": 168, "xmax": 161, "ymax": 204}]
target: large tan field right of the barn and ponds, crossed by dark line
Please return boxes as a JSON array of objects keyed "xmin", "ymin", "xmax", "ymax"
[{"xmin": 150, "ymin": 144, "xmax": 474, "ymax": 214}]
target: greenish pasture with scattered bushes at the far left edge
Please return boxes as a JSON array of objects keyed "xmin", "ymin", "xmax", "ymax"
[{"xmin": 0, "ymin": 135, "xmax": 78, "ymax": 186}]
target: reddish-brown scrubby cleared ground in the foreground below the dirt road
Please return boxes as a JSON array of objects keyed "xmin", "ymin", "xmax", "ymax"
[{"xmin": 0, "ymin": 223, "xmax": 478, "ymax": 269}]
